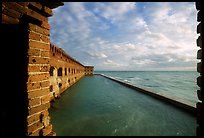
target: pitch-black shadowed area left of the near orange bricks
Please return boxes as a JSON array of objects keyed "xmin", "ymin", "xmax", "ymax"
[{"xmin": 1, "ymin": 24, "xmax": 29, "ymax": 137}]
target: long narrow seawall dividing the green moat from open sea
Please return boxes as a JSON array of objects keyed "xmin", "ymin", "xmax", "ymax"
[{"xmin": 95, "ymin": 74, "xmax": 196, "ymax": 115}]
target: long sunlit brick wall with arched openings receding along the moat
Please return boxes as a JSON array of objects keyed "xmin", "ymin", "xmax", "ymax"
[{"xmin": 50, "ymin": 44, "xmax": 84, "ymax": 100}]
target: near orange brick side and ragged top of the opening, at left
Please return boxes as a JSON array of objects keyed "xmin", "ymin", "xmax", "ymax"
[{"xmin": 2, "ymin": 2, "xmax": 63, "ymax": 136}]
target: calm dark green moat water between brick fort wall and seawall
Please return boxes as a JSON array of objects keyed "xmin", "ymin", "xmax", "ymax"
[{"xmin": 50, "ymin": 75, "xmax": 197, "ymax": 136}]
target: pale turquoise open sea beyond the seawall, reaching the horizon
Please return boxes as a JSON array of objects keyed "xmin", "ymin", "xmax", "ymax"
[{"xmin": 95, "ymin": 71, "xmax": 199, "ymax": 107}]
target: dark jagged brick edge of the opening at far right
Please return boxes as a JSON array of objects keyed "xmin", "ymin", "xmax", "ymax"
[{"xmin": 196, "ymin": 1, "xmax": 204, "ymax": 136}]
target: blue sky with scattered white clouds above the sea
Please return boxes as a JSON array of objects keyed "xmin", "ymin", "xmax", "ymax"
[{"xmin": 49, "ymin": 2, "xmax": 199, "ymax": 71}]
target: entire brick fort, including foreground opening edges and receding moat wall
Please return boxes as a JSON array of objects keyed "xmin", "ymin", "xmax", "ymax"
[{"xmin": 1, "ymin": 2, "xmax": 204, "ymax": 136}]
